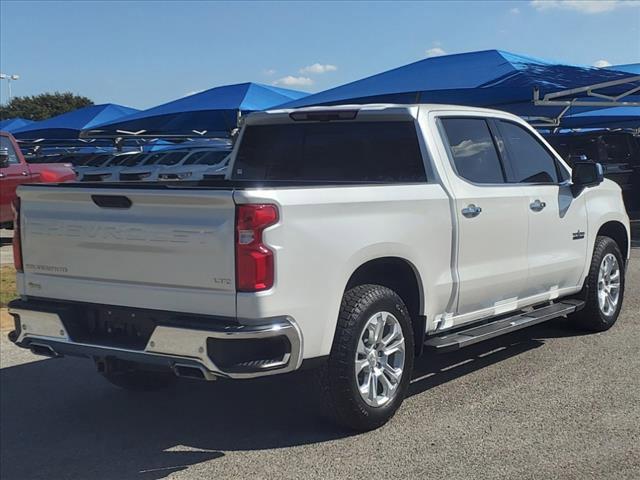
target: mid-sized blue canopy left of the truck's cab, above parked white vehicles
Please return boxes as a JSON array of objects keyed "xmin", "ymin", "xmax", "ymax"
[{"xmin": 83, "ymin": 83, "xmax": 308, "ymax": 138}]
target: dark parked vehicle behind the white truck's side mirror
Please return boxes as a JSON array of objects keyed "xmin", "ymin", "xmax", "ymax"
[{"xmin": 547, "ymin": 130, "xmax": 640, "ymax": 218}]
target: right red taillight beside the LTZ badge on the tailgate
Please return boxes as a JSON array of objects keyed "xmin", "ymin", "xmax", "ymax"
[{"xmin": 236, "ymin": 204, "xmax": 278, "ymax": 292}]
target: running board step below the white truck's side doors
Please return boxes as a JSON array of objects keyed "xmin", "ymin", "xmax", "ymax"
[{"xmin": 424, "ymin": 299, "xmax": 584, "ymax": 353}]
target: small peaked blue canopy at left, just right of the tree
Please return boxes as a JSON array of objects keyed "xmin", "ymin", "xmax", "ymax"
[{"xmin": 13, "ymin": 103, "xmax": 138, "ymax": 142}]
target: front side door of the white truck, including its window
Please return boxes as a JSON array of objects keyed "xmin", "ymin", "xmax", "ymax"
[{"xmin": 495, "ymin": 120, "xmax": 587, "ymax": 299}]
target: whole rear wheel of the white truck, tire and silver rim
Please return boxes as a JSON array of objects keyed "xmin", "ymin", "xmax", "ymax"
[{"xmin": 320, "ymin": 285, "xmax": 414, "ymax": 431}]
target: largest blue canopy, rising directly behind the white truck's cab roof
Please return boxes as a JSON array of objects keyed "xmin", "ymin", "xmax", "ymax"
[{"xmin": 281, "ymin": 50, "xmax": 640, "ymax": 125}]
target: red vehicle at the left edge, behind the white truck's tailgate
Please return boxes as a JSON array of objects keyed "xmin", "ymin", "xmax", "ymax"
[{"xmin": 0, "ymin": 131, "xmax": 76, "ymax": 228}]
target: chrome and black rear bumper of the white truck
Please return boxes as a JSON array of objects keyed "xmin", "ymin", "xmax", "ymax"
[{"xmin": 9, "ymin": 301, "xmax": 302, "ymax": 380}]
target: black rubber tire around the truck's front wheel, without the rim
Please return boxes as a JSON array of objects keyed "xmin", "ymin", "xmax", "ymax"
[{"xmin": 569, "ymin": 236, "xmax": 625, "ymax": 332}]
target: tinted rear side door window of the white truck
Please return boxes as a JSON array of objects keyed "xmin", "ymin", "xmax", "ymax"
[{"xmin": 441, "ymin": 118, "xmax": 505, "ymax": 183}]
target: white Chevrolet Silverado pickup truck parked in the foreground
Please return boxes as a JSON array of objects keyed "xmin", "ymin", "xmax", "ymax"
[{"xmin": 10, "ymin": 105, "xmax": 630, "ymax": 430}]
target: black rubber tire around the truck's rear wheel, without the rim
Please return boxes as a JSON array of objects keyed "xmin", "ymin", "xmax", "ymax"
[{"xmin": 319, "ymin": 285, "xmax": 415, "ymax": 431}]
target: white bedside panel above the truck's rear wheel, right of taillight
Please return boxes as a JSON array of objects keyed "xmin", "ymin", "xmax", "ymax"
[{"xmin": 234, "ymin": 184, "xmax": 452, "ymax": 358}]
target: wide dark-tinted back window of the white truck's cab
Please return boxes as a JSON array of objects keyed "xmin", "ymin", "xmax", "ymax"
[{"xmin": 233, "ymin": 122, "xmax": 427, "ymax": 183}]
